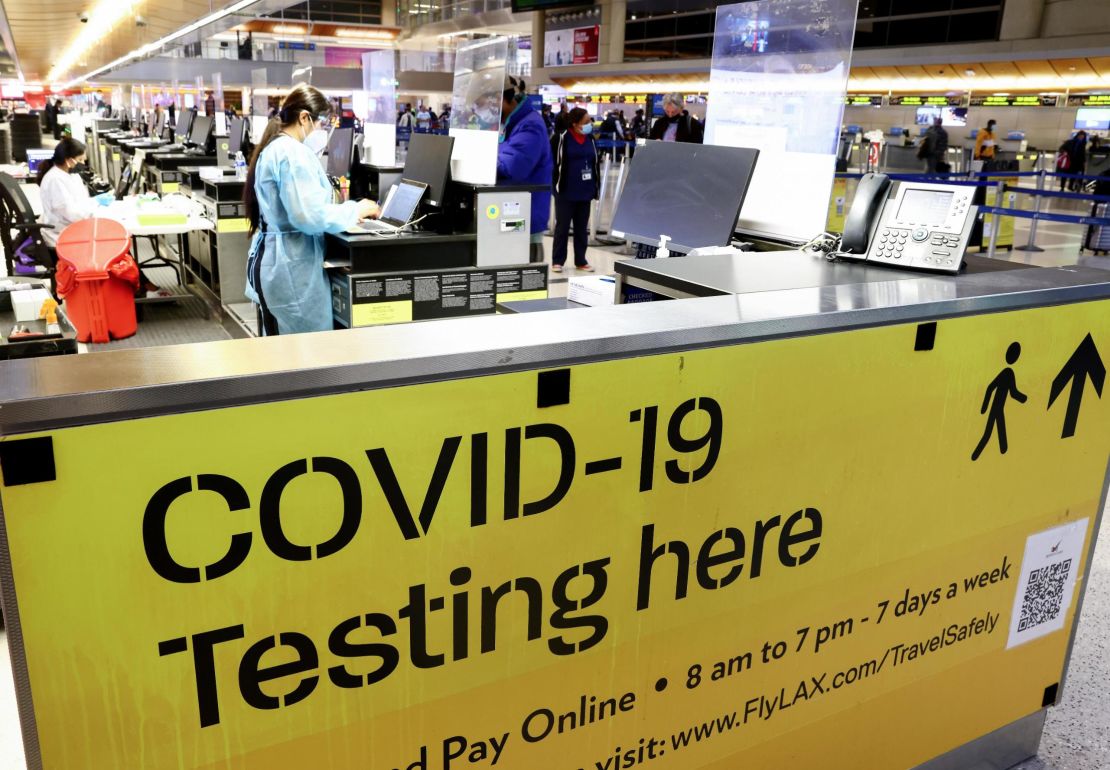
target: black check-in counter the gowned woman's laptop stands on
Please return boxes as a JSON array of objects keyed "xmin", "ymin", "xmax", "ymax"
[{"xmin": 325, "ymin": 133, "xmax": 547, "ymax": 327}]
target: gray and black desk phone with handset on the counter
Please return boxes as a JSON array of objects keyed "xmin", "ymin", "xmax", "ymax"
[{"xmin": 841, "ymin": 174, "xmax": 979, "ymax": 273}]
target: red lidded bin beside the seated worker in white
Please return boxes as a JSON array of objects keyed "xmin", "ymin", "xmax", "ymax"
[{"xmin": 57, "ymin": 219, "xmax": 139, "ymax": 342}]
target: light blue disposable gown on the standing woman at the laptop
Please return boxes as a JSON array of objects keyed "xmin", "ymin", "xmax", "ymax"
[{"xmin": 246, "ymin": 134, "xmax": 359, "ymax": 334}]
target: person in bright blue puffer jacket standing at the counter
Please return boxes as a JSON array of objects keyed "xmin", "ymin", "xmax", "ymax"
[{"xmin": 497, "ymin": 77, "xmax": 552, "ymax": 262}]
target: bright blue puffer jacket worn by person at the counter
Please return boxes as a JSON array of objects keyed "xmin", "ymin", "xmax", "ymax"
[{"xmin": 497, "ymin": 102, "xmax": 552, "ymax": 233}]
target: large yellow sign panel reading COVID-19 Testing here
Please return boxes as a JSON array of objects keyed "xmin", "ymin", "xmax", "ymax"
[{"xmin": 0, "ymin": 302, "xmax": 1110, "ymax": 770}]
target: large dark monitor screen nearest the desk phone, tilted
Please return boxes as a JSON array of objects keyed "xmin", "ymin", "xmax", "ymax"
[{"xmin": 612, "ymin": 142, "xmax": 759, "ymax": 251}]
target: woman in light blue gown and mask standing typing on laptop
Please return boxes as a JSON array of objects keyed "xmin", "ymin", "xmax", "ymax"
[{"xmin": 243, "ymin": 83, "xmax": 379, "ymax": 335}]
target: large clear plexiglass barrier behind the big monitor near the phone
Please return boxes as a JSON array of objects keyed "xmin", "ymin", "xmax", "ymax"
[{"xmin": 705, "ymin": 0, "xmax": 857, "ymax": 240}]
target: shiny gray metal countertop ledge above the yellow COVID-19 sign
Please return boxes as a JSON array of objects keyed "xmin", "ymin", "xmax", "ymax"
[{"xmin": 0, "ymin": 255, "xmax": 1110, "ymax": 434}]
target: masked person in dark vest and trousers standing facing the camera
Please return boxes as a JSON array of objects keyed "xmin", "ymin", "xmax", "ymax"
[{"xmin": 552, "ymin": 108, "xmax": 601, "ymax": 273}]
